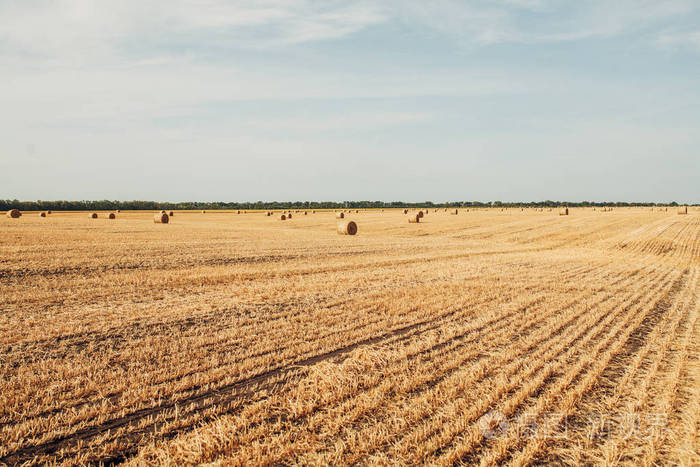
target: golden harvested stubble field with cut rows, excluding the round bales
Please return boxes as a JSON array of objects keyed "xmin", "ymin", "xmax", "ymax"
[{"xmin": 0, "ymin": 208, "xmax": 700, "ymax": 465}]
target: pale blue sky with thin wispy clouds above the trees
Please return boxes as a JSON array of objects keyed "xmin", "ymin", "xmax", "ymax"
[{"xmin": 0, "ymin": 0, "xmax": 700, "ymax": 203}]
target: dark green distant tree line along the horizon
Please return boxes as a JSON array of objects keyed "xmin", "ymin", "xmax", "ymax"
[{"xmin": 0, "ymin": 199, "xmax": 692, "ymax": 211}]
